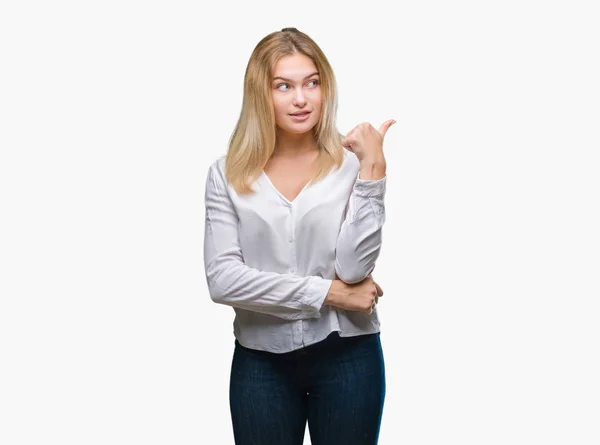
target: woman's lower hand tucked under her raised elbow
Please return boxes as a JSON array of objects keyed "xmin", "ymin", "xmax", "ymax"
[{"xmin": 323, "ymin": 276, "xmax": 383, "ymax": 315}]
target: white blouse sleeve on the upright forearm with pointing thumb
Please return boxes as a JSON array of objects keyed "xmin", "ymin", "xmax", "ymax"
[{"xmin": 335, "ymin": 174, "xmax": 387, "ymax": 284}]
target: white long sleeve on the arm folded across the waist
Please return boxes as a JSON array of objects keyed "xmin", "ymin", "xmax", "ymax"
[{"xmin": 204, "ymin": 164, "xmax": 333, "ymax": 320}]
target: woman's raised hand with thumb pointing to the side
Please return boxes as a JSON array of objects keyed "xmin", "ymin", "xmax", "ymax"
[{"xmin": 342, "ymin": 119, "xmax": 396, "ymax": 163}]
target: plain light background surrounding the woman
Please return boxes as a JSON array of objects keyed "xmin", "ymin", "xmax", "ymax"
[{"xmin": 0, "ymin": 0, "xmax": 600, "ymax": 445}]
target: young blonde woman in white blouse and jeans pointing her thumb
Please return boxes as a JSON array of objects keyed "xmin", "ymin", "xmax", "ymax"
[{"xmin": 204, "ymin": 28, "xmax": 395, "ymax": 445}]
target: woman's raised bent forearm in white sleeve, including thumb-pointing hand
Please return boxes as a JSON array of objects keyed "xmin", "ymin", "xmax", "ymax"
[{"xmin": 335, "ymin": 120, "xmax": 395, "ymax": 284}]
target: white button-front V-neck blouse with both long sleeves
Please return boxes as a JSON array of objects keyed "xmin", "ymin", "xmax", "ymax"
[{"xmin": 204, "ymin": 149, "xmax": 387, "ymax": 353}]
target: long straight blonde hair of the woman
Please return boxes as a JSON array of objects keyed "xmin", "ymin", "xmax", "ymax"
[{"xmin": 225, "ymin": 28, "xmax": 345, "ymax": 194}]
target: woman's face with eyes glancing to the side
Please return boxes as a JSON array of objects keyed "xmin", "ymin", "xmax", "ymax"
[{"xmin": 271, "ymin": 54, "xmax": 321, "ymax": 134}]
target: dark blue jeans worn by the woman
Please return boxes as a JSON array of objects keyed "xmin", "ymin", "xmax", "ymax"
[{"xmin": 229, "ymin": 331, "xmax": 385, "ymax": 445}]
